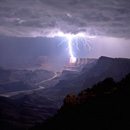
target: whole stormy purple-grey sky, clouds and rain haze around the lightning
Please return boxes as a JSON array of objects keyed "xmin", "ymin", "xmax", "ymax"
[{"xmin": 0, "ymin": 0, "xmax": 130, "ymax": 68}]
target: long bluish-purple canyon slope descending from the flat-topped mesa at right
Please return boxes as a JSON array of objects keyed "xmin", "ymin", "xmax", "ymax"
[{"xmin": 43, "ymin": 57, "xmax": 130, "ymax": 103}]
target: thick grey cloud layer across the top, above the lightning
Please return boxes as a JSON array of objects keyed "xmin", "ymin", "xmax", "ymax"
[{"xmin": 0, "ymin": 0, "xmax": 130, "ymax": 38}]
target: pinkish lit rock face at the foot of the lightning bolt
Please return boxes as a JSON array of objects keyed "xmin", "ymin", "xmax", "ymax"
[{"xmin": 64, "ymin": 58, "xmax": 97, "ymax": 71}]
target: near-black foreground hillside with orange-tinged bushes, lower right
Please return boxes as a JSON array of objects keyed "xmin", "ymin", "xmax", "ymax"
[{"xmin": 31, "ymin": 74, "xmax": 130, "ymax": 130}]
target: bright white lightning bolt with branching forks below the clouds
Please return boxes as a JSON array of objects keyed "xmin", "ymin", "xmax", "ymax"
[{"xmin": 58, "ymin": 32, "xmax": 93, "ymax": 63}]
